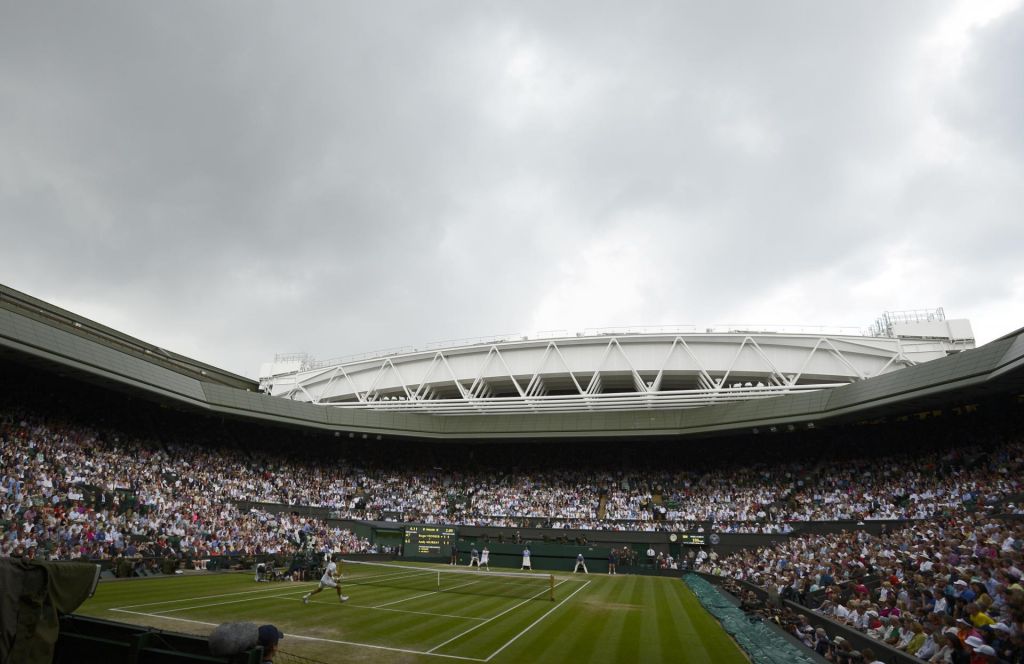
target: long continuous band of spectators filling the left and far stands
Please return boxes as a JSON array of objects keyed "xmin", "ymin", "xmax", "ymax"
[{"xmin": 0, "ymin": 401, "xmax": 1024, "ymax": 557}]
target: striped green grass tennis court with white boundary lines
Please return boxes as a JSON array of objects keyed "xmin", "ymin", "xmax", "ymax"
[{"xmin": 79, "ymin": 564, "xmax": 745, "ymax": 662}]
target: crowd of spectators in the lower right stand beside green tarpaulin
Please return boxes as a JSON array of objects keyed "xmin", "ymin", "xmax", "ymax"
[{"xmin": 696, "ymin": 513, "xmax": 1024, "ymax": 664}]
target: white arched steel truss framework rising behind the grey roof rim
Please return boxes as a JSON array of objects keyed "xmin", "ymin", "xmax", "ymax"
[{"xmin": 261, "ymin": 333, "xmax": 965, "ymax": 415}]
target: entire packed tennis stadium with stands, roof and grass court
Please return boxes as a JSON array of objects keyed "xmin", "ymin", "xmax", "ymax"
[{"xmin": 0, "ymin": 280, "xmax": 1024, "ymax": 664}]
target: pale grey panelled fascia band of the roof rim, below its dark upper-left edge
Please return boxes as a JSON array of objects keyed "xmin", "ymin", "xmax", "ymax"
[{"xmin": 0, "ymin": 286, "xmax": 1024, "ymax": 439}]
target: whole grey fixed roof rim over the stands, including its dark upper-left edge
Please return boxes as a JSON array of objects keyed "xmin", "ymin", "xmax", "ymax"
[{"xmin": 0, "ymin": 286, "xmax": 1024, "ymax": 440}]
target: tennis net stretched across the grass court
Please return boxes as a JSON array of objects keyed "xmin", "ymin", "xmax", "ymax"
[{"xmin": 341, "ymin": 561, "xmax": 555, "ymax": 600}]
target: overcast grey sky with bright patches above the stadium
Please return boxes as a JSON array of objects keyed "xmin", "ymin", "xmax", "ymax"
[{"xmin": 0, "ymin": 0, "xmax": 1024, "ymax": 377}]
